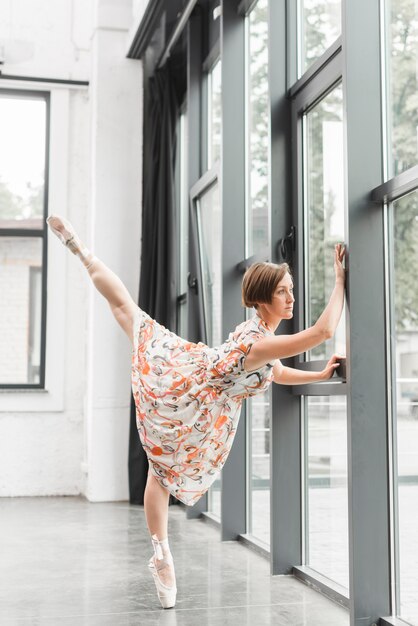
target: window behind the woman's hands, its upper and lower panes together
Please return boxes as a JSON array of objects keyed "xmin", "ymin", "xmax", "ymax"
[{"xmin": 294, "ymin": 75, "xmax": 349, "ymax": 595}]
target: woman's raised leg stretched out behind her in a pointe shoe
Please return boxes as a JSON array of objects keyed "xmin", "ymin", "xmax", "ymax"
[{"xmin": 47, "ymin": 216, "xmax": 138, "ymax": 341}]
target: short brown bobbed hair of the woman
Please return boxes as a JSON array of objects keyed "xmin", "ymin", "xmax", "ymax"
[{"xmin": 242, "ymin": 263, "xmax": 290, "ymax": 308}]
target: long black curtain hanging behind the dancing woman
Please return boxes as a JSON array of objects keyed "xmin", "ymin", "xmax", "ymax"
[{"xmin": 129, "ymin": 64, "xmax": 179, "ymax": 504}]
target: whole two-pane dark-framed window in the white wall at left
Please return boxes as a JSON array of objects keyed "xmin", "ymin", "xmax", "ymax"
[{"xmin": 0, "ymin": 91, "xmax": 47, "ymax": 387}]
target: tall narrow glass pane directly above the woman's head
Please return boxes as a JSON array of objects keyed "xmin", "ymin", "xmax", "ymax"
[{"xmin": 246, "ymin": 0, "xmax": 270, "ymax": 257}]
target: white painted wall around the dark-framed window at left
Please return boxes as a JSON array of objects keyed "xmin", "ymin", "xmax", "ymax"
[{"xmin": 0, "ymin": 0, "xmax": 142, "ymax": 500}]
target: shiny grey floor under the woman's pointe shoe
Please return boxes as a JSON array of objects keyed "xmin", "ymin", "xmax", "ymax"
[{"xmin": 0, "ymin": 498, "xmax": 349, "ymax": 626}]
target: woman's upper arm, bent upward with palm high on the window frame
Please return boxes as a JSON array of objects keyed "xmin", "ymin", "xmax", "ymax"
[{"xmin": 247, "ymin": 244, "xmax": 345, "ymax": 370}]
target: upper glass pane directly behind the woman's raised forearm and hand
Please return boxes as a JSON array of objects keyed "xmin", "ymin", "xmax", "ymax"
[{"xmin": 305, "ymin": 85, "xmax": 345, "ymax": 359}]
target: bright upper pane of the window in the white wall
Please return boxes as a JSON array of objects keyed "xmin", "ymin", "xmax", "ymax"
[{"xmin": 0, "ymin": 94, "xmax": 46, "ymax": 228}]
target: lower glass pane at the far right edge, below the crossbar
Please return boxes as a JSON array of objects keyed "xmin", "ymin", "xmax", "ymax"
[{"xmin": 392, "ymin": 192, "xmax": 418, "ymax": 624}]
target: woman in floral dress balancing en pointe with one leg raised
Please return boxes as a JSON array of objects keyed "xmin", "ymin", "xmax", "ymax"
[{"xmin": 47, "ymin": 216, "xmax": 345, "ymax": 608}]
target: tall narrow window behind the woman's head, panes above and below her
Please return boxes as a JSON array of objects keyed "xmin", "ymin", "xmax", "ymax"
[{"xmin": 246, "ymin": 0, "xmax": 271, "ymax": 544}]
